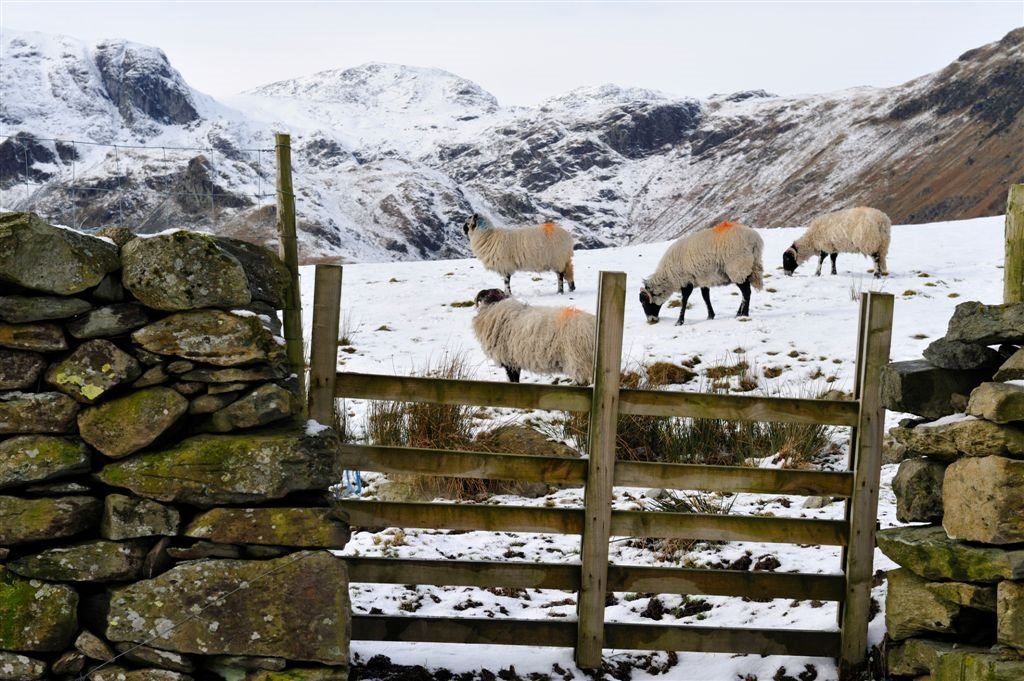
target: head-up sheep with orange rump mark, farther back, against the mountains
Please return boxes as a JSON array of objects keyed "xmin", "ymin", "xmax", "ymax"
[{"xmin": 462, "ymin": 213, "xmax": 575, "ymax": 296}]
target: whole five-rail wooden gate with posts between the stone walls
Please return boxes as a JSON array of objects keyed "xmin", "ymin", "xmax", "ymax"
[{"xmin": 310, "ymin": 266, "xmax": 893, "ymax": 679}]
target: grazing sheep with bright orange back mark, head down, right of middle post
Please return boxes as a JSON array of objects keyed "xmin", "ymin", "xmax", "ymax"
[{"xmin": 640, "ymin": 222, "xmax": 764, "ymax": 327}]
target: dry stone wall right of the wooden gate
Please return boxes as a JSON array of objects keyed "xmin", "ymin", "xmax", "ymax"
[{"xmin": 878, "ymin": 302, "xmax": 1024, "ymax": 681}]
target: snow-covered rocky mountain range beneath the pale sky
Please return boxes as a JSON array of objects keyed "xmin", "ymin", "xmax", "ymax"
[{"xmin": 0, "ymin": 29, "xmax": 1024, "ymax": 261}]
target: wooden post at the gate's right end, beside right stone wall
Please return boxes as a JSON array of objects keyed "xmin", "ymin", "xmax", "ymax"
[{"xmin": 839, "ymin": 292, "xmax": 894, "ymax": 681}]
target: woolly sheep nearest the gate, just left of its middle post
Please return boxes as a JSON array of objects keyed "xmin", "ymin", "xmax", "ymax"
[{"xmin": 473, "ymin": 289, "xmax": 597, "ymax": 385}]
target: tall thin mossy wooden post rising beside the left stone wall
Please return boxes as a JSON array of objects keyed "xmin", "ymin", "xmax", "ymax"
[{"xmin": 274, "ymin": 132, "xmax": 306, "ymax": 412}]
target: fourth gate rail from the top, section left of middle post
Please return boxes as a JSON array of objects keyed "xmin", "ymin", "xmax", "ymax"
[{"xmin": 345, "ymin": 556, "xmax": 581, "ymax": 591}]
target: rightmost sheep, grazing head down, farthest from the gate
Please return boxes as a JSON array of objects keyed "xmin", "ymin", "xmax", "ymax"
[{"xmin": 782, "ymin": 206, "xmax": 892, "ymax": 278}]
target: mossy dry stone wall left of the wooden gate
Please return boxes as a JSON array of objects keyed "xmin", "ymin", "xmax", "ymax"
[{"xmin": 0, "ymin": 213, "xmax": 349, "ymax": 681}]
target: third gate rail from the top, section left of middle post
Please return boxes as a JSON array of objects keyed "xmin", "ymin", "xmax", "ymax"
[{"xmin": 335, "ymin": 499, "xmax": 583, "ymax": 535}]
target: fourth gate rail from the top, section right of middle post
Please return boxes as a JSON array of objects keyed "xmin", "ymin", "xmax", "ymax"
[{"xmin": 608, "ymin": 565, "xmax": 846, "ymax": 601}]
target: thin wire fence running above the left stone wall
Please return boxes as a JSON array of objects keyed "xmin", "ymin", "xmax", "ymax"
[{"xmin": 0, "ymin": 132, "xmax": 276, "ymax": 232}]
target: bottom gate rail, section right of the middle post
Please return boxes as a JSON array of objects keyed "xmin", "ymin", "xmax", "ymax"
[{"xmin": 605, "ymin": 624, "xmax": 839, "ymax": 657}]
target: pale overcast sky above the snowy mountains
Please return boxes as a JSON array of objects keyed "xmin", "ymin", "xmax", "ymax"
[{"xmin": 0, "ymin": 0, "xmax": 1024, "ymax": 104}]
